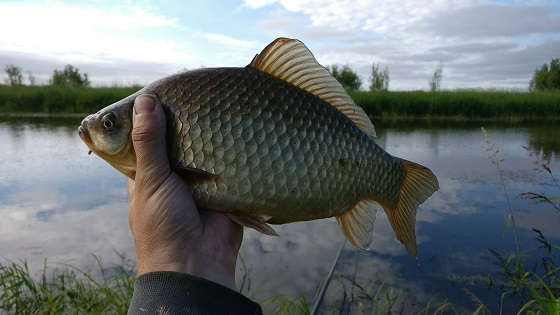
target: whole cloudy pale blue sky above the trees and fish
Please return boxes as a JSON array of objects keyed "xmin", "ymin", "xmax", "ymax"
[{"xmin": 0, "ymin": 0, "xmax": 560, "ymax": 90}]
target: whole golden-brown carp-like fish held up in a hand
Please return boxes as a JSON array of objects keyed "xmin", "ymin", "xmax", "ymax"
[{"xmin": 78, "ymin": 38, "xmax": 439, "ymax": 257}]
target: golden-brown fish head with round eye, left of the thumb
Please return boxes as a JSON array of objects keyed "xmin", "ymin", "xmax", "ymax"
[{"xmin": 78, "ymin": 96, "xmax": 136, "ymax": 179}]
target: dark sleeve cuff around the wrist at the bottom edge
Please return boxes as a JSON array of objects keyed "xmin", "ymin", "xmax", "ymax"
[{"xmin": 128, "ymin": 271, "xmax": 262, "ymax": 315}]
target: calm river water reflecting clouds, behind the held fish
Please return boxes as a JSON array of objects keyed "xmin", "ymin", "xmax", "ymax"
[{"xmin": 0, "ymin": 118, "xmax": 560, "ymax": 312}]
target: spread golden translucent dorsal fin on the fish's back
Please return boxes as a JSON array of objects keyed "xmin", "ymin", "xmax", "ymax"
[{"xmin": 249, "ymin": 37, "xmax": 375, "ymax": 137}]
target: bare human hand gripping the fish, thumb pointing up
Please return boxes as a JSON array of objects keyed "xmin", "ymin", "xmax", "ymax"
[{"xmin": 127, "ymin": 94, "xmax": 243, "ymax": 289}]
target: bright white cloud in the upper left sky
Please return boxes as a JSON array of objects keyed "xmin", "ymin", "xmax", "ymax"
[{"xmin": 0, "ymin": 3, "xmax": 200, "ymax": 84}]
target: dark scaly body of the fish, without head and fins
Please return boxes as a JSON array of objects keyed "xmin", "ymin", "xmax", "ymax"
[{"xmin": 147, "ymin": 68, "xmax": 404, "ymax": 223}]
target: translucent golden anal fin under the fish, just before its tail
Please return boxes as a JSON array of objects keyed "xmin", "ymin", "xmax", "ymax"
[{"xmin": 336, "ymin": 200, "xmax": 379, "ymax": 249}]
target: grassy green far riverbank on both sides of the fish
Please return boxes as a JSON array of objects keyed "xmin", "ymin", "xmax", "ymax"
[{"xmin": 0, "ymin": 86, "xmax": 560, "ymax": 120}]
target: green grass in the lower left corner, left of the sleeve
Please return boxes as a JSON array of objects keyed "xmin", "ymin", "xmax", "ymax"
[{"xmin": 0, "ymin": 258, "xmax": 134, "ymax": 314}]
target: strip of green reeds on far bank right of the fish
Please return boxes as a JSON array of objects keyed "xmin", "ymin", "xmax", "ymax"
[{"xmin": 350, "ymin": 90, "xmax": 560, "ymax": 119}]
